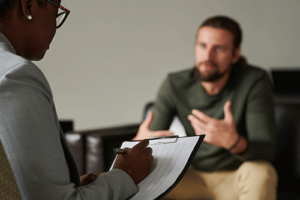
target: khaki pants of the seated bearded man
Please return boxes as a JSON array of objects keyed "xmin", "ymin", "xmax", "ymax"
[{"xmin": 163, "ymin": 161, "xmax": 277, "ymax": 200}]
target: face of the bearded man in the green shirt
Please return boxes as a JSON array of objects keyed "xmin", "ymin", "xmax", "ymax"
[{"xmin": 195, "ymin": 26, "xmax": 240, "ymax": 82}]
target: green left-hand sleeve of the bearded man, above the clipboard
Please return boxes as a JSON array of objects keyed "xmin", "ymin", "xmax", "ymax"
[{"xmin": 150, "ymin": 76, "xmax": 176, "ymax": 131}]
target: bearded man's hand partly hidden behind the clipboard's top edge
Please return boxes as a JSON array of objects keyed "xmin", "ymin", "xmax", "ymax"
[{"xmin": 133, "ymin": 111, "xmax": 174, "ymax": 140}]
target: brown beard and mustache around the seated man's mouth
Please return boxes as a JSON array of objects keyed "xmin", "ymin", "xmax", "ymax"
[{"xmin": 197, "ymin": 61, "xmax": 225, "ymax": 82}]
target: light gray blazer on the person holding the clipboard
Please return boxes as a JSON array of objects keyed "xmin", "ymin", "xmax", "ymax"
[{"xmin": 0, "ymin": 33, "xmax": 137, "ymax": 200}]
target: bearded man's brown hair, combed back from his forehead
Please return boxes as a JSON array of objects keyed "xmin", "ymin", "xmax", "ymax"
[{"xmin": 197, "ymin": 16, "xmax": 242, "ymax": 48}]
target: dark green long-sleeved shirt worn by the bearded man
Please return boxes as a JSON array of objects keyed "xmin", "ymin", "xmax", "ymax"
[{"xmin": 150, "ymin": 63, "xmax": 275, "ymax": 171}]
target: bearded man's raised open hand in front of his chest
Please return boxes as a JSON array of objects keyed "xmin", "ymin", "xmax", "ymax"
[{"xmin": 188, "ymin": 101, "xmax": 238, "ymax": 149}]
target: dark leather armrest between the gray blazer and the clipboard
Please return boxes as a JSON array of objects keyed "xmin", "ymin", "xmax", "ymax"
[{"xmin": 65, "ymin": 124, "xmax": 140, "ymax": 175}]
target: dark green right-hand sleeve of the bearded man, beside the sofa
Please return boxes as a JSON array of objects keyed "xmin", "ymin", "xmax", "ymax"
[{"xmin": 233, "ymin": 72, "xmax": 276, "ymax": 161}]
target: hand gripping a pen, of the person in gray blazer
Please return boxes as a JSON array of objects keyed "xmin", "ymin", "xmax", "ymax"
[{"xmin": 113, "ymin": 140, "xmax": 153, "ymax": 184}]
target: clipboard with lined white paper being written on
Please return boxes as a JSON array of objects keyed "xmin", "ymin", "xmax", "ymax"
[{"xmin": 110, "ymin": 135, "xmax": 205, "ymax": 200}]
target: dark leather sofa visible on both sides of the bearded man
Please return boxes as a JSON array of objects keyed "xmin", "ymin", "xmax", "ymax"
[{"xmin": 66, "ymin": 100, "xmax": 300, "ymax": 200}]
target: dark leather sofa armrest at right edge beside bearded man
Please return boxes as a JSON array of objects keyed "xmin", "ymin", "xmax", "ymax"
[{"xmin": 272, "ymin": 101, "xmax": 300, "ymax": 194}]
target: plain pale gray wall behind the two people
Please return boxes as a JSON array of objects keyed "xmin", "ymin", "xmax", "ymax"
[{"xmin": 36, "ymin": 0, "xmax": 300, "ymax": 130}]
